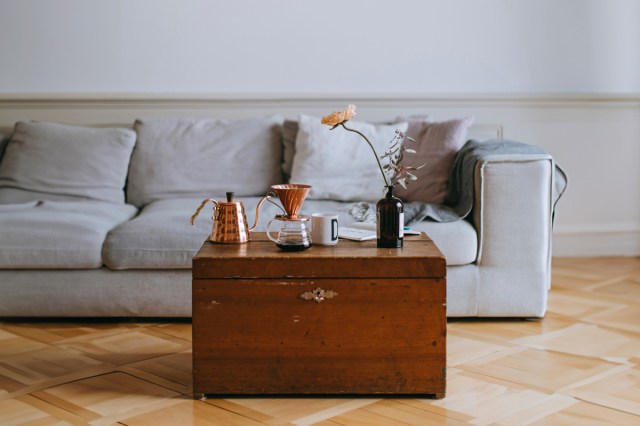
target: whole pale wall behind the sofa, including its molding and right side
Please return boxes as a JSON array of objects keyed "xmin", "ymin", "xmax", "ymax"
[{"xmin": 0, "ymin": 0, "xmax": 640, "ymax": 255}]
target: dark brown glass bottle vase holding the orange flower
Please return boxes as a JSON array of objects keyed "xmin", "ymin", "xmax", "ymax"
[{"xmin": 376, "ymin": 186, "xmax": 404, "ymax": 248}]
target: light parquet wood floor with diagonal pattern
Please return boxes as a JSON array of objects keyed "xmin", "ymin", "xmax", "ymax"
[{"xmin": 0, "ymin": 258, "xmax": 640, "ymax": 426}]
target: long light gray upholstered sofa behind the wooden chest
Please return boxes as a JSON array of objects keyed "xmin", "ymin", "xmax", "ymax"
[{"xmin": 0, "ymin": 116, "xmax": 554, "ymax": 317}]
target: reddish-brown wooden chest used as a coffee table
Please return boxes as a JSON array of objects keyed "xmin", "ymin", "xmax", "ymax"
[{"xmin": 193, "ymin": 233, "xmax": 447, "ymax": 398}]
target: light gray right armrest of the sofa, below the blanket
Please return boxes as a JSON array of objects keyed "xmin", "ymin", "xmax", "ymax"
[{"xmin": 473, "ymin": 154, "xmax": 554, "ymax": 317}]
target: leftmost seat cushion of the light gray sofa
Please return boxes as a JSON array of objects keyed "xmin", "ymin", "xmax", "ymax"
[{"xmin": 0, "ymin": 201, "xmax": 137, "ymax": 269}]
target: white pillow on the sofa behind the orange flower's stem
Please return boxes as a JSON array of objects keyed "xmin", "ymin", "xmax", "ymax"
[{"xmin": 291, "ymin": 115, "xmax": 407, "ymax": 201}]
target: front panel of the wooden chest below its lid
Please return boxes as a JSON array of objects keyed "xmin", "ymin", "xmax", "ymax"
[{"xmin": 193, "ymin": 278, "xmax": 446, "ymax": 397}]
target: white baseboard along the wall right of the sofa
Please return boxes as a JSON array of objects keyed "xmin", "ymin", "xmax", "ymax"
[{"xmin": 553, "ymin": 230, "xmax": 640, "ymax": 257}]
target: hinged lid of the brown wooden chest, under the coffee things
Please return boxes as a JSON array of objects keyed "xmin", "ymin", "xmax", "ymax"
[{"xmin": 193, "ymin": 233, "xmax": 446, "ymax": 279}]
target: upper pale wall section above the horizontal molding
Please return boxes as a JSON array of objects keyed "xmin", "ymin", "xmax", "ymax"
[{"xmin": 0, "ymin": 0, "xmax": 640, "ymax": 93}]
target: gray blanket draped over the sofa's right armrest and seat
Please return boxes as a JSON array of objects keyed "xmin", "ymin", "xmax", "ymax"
[{"xmin": 349, "ymin": 139, "xmax": 567, "ymax": 225}]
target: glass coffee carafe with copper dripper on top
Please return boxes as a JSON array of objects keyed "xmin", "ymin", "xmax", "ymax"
[{"xmin": 267, "ymin": 183, "xmax": 311, "ymax": 251}]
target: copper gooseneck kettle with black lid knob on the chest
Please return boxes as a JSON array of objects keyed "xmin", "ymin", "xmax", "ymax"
[{"xmin": 190, "ymin": 192, "xmax": 268, "ymax": 244}]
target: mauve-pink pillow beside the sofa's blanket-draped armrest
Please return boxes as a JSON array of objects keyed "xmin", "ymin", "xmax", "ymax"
[{"xmin": 395, "ymin": 117, "xmax": 474, "ymax": 204}]
